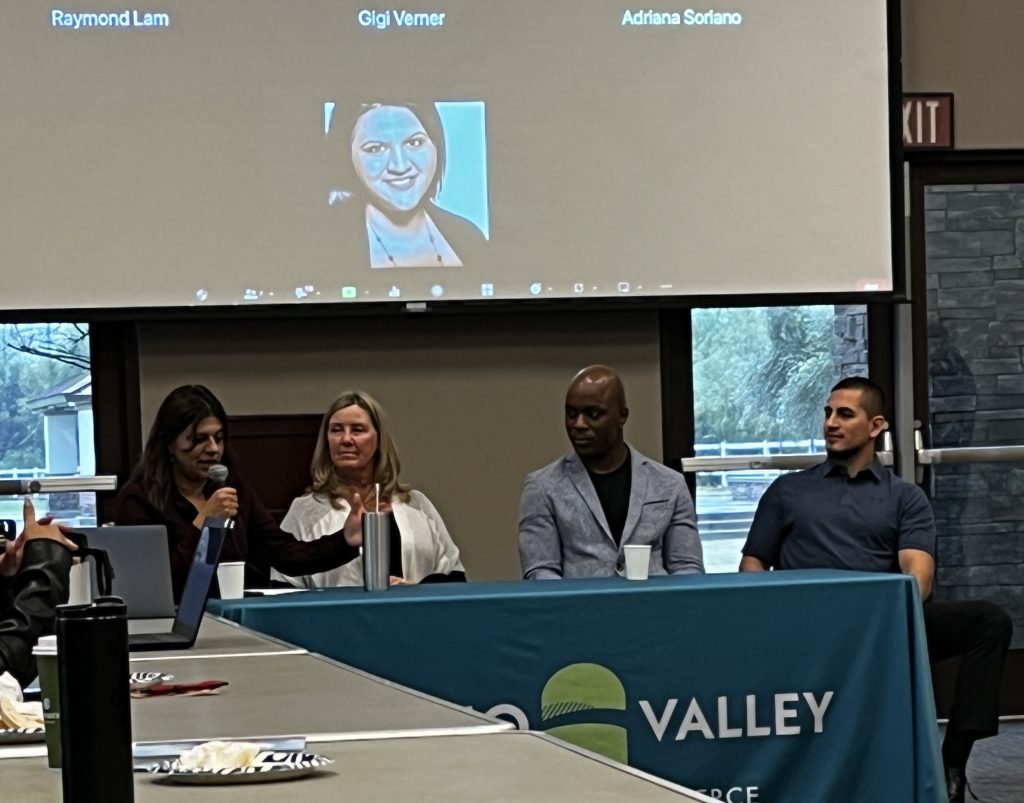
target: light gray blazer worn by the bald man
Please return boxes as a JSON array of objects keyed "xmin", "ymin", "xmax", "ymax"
[{"xmin": 519, "ymin": 449, "xmax": 703, "ymax": 580}]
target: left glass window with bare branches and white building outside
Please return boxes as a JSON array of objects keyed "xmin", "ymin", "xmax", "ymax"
[{"xmin": 0, "ymin": 324, "xmax": 96, "ymax": 526}]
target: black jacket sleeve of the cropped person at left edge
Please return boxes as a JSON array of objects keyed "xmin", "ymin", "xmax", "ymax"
[{"xmin": 0, "ymin": 539, "xmax": 72, "ymax": 686}]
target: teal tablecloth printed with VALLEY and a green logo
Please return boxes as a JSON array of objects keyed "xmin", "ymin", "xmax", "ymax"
[{"xmin": 210, "ymin": 570, "xmax": 945, "ymax": 803}]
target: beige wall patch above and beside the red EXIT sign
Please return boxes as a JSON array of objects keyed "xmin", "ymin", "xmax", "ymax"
[{"xmin": 902, "ymin": 0, "xmax": 1024, "ymax": 150}]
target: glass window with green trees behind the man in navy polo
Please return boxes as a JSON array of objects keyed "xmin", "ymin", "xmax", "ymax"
[{"xmin": 691, "ymin": 305, "xmax": 867, "ymax": 572}]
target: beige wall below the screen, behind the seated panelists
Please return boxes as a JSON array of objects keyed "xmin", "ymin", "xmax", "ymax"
[{"xmin": 139, "ymin": 312, "xmax": 662, "ymax": 580}]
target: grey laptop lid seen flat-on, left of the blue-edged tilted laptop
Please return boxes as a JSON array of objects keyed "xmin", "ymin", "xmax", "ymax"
[{"xmin": 80, "ymin": 524, "xmax": 174, "ymax": 620}]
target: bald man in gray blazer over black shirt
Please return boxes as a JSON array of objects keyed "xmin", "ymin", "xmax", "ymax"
[{"xmin": 519, "ymin": 366, "xmax": 703, "ymax": 580}]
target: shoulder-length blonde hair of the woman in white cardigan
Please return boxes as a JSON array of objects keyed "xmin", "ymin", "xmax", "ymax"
[{"xmin": 308, "ymin": 390, "xmax": 412, "ymax": 509}]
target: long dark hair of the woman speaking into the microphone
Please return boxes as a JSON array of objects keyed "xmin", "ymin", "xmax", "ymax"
[{"xmin": 132, "ymin": 385, "xmax": 229, "ymax": 519}]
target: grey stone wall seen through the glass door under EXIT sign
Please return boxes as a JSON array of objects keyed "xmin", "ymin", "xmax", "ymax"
[{"xmin": 925, "ymin": 184, "xmax": 1024, "ymax": 646}]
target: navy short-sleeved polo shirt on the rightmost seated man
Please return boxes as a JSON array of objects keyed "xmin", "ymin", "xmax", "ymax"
[{"xmin": 743, "ymin": 460, "xmax": 935, "ymax": 573}]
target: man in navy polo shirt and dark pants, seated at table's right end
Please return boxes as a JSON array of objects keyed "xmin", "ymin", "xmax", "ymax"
[{"xmin": 739, "ymin": 377, "xmax": 1012, "ymax": 801}]
